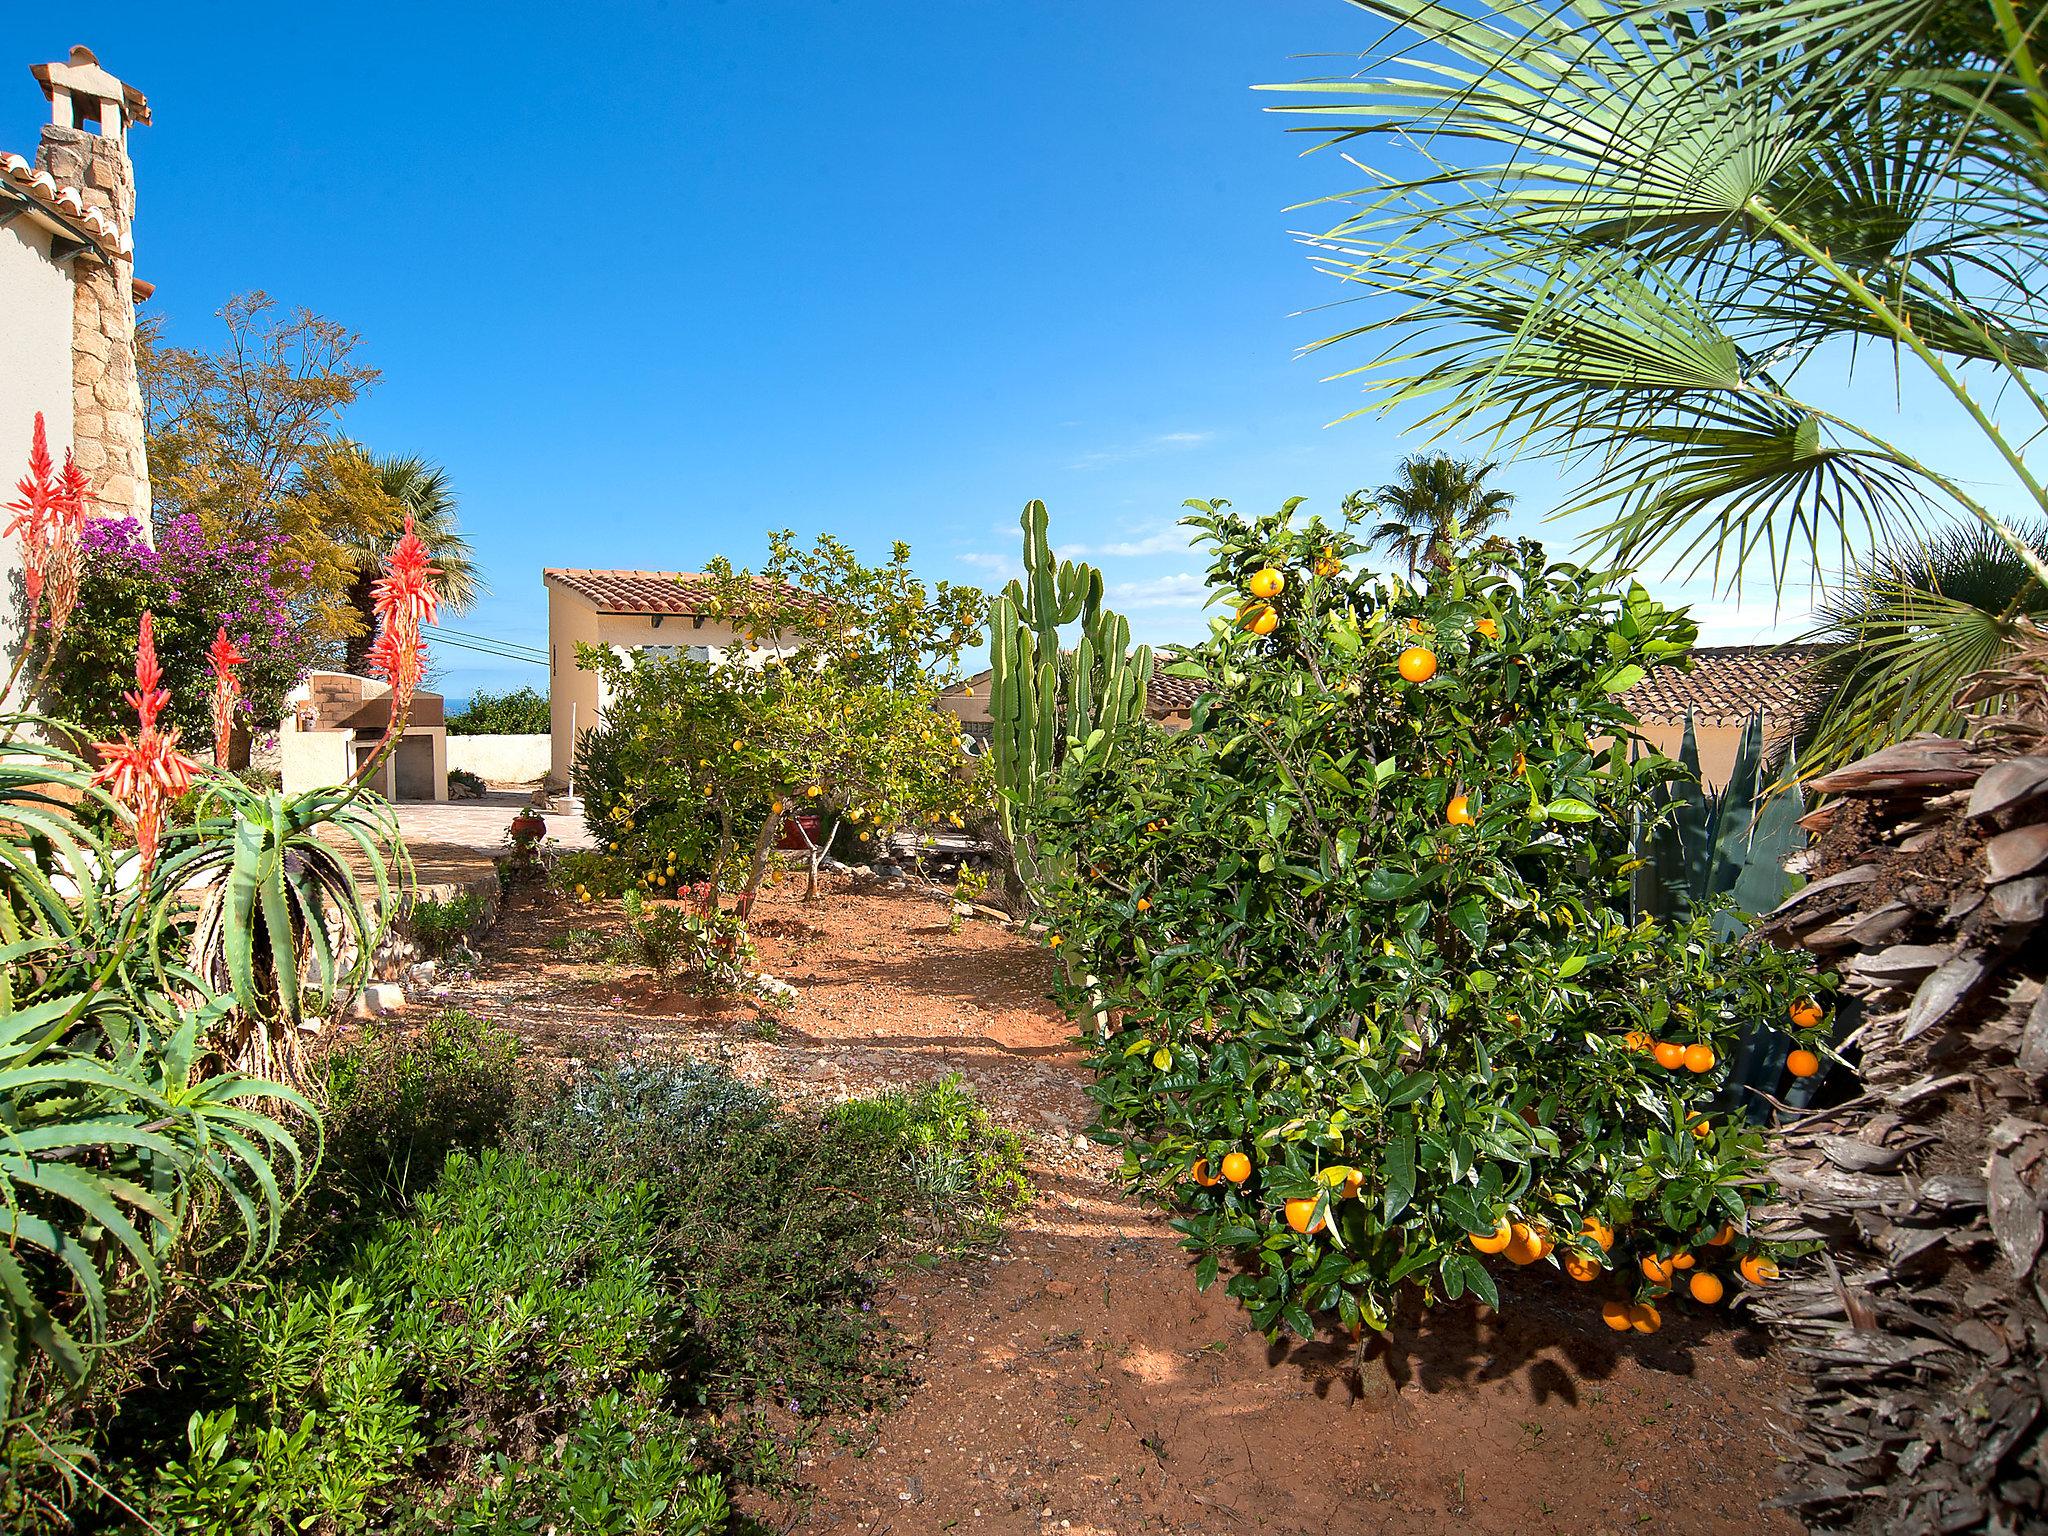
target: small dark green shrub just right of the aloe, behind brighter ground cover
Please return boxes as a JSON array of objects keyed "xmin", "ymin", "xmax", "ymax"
[{"xmin": 326, "ymin": 1010, "xmax": 520, "ymax": 1204}]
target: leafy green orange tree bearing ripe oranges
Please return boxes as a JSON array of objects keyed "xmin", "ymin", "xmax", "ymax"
[{"xmin": 1034, "ymin": 502, "xmax": 1817, "ymax": 1335}]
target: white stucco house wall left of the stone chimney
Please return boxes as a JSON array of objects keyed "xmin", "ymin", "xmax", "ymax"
[{"xmin": 0, "ymin": 219, "xmax": 72, "ymax": 692}]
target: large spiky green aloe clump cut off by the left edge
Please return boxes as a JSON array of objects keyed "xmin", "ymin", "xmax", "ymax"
[{"xmin": 0, "ymin": 717, "xmax": 311, "ymax": 1413}]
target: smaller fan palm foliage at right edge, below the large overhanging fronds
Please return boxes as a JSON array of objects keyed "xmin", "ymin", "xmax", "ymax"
[{"xmin": 1792, "ymin": 524, "xmax": 2048, "ymax": 776}]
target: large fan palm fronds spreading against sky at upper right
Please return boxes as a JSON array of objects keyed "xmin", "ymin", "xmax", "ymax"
[{"xmin": 1276, "ymin": 0, "xmax": 2048, "ymax": 592}]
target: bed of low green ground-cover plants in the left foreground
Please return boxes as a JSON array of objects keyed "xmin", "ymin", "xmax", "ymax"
[{"xmin": 27, "ymin": 1012, "xmax": 1028, "ymax": 1536}]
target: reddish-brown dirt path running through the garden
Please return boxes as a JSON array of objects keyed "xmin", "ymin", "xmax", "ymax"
[{"xmin": 446, "ymin": 876, "xmax": 1798, "ymax": 1536}]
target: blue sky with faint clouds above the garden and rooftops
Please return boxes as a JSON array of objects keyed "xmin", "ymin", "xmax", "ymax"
[{"xmin": 16, "ymin": 0, "xmax": 2015, "ymax": 696}]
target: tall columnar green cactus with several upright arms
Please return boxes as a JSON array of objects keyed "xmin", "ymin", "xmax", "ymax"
[{"xmin": 989, "ymin": 502, "xmax": 1153, "ymax": 897}]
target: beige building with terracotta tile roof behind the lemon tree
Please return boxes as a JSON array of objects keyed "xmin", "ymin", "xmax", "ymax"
[{"xmin": 541, "ymin": 569, "xmax": 794, "ymax": 786}]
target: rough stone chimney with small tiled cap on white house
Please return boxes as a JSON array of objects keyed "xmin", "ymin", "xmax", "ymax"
[{"xmin": 29, "ymin": 47, "xmax": 150, "ymax": 537}]
